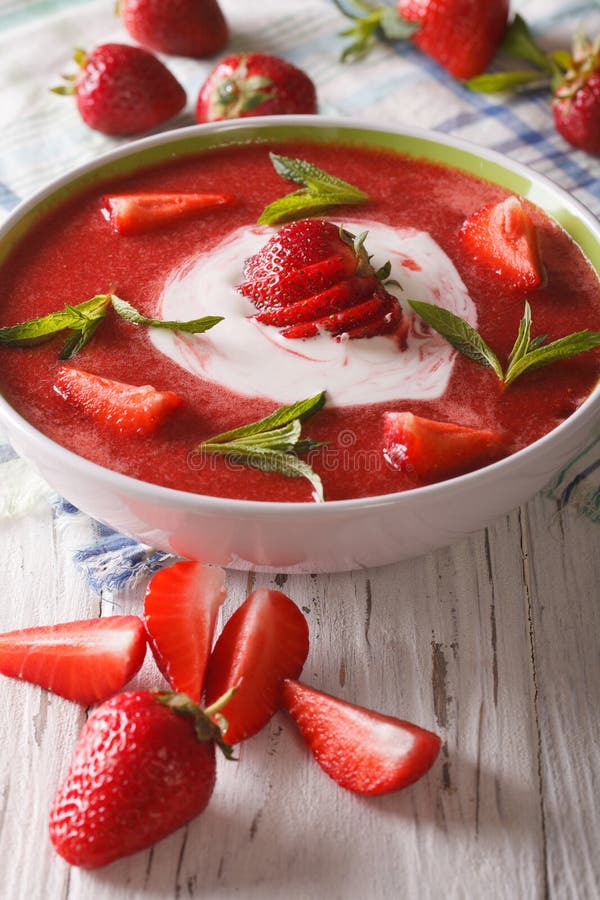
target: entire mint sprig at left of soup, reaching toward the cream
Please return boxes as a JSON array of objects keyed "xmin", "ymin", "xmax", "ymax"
[{"xmin": 0, "ymin": 294, "xmax": 223, "ymax": 359}]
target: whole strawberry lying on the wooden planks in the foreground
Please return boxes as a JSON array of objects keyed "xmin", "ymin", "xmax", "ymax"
[{"xmin": 50, "ymin": 691, "xmax": 229, "ymax": 868}]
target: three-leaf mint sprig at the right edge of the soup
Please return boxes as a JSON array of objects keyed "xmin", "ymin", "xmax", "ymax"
[{"xmin": 408, "ymin": 300, "xmax": 600, "ymax": 387}]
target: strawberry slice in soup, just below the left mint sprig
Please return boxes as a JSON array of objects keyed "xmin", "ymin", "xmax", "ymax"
[{"xmin": 54, "ymin": 366, "xmax": 183, "ymax": 437}]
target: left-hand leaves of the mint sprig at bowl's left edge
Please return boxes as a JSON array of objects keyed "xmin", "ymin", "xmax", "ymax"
[{"xmin": 0, "ymin": 294, "xmax": 111, "ymax": 359}]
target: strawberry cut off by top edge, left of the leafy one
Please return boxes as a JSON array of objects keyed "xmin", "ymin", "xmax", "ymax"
[{"xmin": 117, "ymin": 0, "xmax": 229, "ymax": 59}]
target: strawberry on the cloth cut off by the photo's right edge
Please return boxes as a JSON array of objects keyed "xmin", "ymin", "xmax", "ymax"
[{"xmin": 552, "ymin": 35, "xmax": 600, "ymax": 156}]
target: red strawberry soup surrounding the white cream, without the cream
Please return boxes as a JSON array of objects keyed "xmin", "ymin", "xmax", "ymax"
[{"xmin": 0, "ymin": 143, "xmax": 600, "ymax": 501}]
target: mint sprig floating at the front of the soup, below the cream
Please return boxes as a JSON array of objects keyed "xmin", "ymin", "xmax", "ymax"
[{"xmin": 196, "ymin": 391, "xmax": 325, "ymax": 501}]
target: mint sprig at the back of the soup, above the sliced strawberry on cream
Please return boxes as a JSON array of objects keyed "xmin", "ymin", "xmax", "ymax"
[{"xmin": 258, "ymin": 153, "xmax": 369, "ymax": 225}]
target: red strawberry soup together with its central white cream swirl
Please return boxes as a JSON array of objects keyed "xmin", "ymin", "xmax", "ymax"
[{"xmin": 0, "ymin": 141, "xmax": 600, "ymax": 501}]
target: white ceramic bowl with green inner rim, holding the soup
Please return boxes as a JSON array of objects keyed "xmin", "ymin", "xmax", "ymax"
[{"xmin": 0, "ymin": 116, "xmax": 600, "ymax": 572}]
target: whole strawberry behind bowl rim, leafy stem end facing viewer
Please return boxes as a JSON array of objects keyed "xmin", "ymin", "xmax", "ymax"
[{"xmin": 196, "ymin": 53, "xmax": 317, "ymax": 122}]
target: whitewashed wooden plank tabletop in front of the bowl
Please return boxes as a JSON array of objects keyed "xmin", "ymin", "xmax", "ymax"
[{"xmin": 0, "ymin": 488, "xmax": 600, "ymax": 900}]
